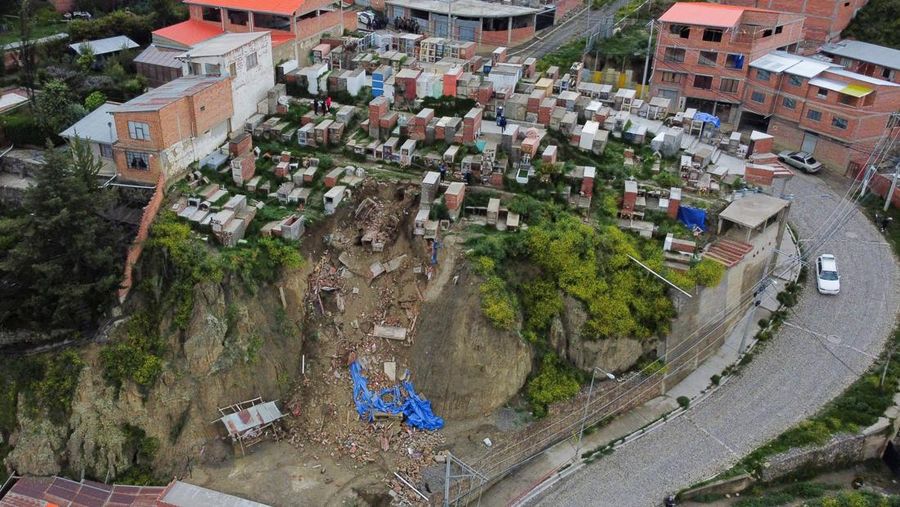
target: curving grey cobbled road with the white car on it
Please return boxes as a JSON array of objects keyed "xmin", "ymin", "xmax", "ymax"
[{"xmin": 539, "ymin": 174, "xmax": 900, "ymax": 507}]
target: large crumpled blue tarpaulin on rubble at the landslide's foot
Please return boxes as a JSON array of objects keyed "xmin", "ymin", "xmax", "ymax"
[{"xmin": 350, "ymin": 361, "xmax": 444, "ymax": 430}]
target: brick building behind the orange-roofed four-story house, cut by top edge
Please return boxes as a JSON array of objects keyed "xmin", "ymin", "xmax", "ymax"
[{"xmin": 722, "ymin": 0, "xmax": 868, "ymax": 43}]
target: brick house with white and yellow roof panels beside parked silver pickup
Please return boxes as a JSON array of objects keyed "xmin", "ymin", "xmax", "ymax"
[{"xmin": 742, "ymin": 51, "xmax": 900, "ymax": 174}]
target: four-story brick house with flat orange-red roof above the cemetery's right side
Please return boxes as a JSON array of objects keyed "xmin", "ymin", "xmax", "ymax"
[{"xmin": 650, "ymin": 2, "xmax": 803, "ymax": 124}]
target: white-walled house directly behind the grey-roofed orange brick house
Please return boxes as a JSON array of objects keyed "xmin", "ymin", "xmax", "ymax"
[{"xmin": 178, "ymin": 32, "xmax": 275, "ymax": 129}]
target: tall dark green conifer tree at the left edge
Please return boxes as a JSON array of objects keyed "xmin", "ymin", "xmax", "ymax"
[{"xmin": 0, "ymin": 140, "xmax": 124, "ymax": 329}]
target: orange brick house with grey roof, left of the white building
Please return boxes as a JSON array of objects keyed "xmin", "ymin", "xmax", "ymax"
[{"xmin": 110, "ymin": 76, "xmax": 234, "ymax": 183}]
